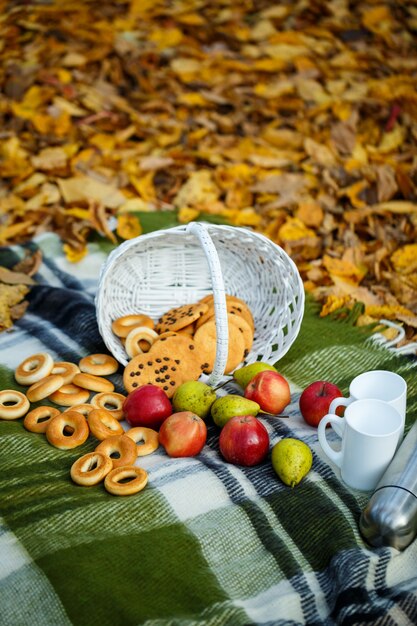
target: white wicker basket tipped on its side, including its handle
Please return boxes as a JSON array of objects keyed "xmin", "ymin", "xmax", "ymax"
[{"xmin": 96, "ymin": 222, "xmax": 304, "ymax": 385}]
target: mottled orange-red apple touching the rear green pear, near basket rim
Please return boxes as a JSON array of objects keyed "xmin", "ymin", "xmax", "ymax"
[{"xmin": 244, "ymin": 370, "xmax": 291, "ymax": 415}]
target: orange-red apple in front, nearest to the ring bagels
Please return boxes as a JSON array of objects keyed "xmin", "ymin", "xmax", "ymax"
[{"xmin": 159, "ymin": 411, "xmax": 207, "ymax": 457}]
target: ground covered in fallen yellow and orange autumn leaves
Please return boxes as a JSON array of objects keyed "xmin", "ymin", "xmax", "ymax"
[{"xmin": 0, "ymin": 0, "xmax": 417, "ymax": 342}]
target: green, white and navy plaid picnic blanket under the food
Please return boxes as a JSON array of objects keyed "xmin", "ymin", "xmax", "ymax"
[{"xmin": 0, "ymin": 230, "xmax": 417, "ymax": 626}]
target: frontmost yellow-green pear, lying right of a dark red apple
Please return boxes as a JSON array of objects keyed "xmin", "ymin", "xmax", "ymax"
[{"xmin": 271, "ymin": 437, "xmax": 313, "ymax": 487}]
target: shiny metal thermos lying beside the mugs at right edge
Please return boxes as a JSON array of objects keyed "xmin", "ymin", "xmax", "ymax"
[{"xmin": 359, "ymin": 421, "xmax": 417, "ymax": 550}]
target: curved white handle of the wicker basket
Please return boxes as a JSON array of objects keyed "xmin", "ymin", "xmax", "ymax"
[{"xmin": 186, "ymin": 222, "xmax": 229, "ymax": 385}]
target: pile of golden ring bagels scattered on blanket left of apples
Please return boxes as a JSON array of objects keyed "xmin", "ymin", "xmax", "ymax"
[{"xmin": 0, "ymin": 352, "xmax": 152, "ymax": 496}]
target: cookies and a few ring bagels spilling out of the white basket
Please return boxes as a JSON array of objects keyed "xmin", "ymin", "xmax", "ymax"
[{"xmin": 112, "ymin": 295, "xmax": 255, "ymax": 398}]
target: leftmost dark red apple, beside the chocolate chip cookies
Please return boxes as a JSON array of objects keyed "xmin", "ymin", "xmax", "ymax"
[{"xmin": 123, "ymin": 384, "xmax": 172, "ymax": 430}]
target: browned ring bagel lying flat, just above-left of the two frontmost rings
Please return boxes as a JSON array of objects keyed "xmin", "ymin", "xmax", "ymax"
[{"xmin": 45, "ymin": 411, "xmax": 90, "ymax": 450}]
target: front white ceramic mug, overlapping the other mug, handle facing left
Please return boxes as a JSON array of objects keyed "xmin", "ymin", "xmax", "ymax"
[{"xmin": 318, "ymin": 399, "xmax": 403, "ymax": 491}]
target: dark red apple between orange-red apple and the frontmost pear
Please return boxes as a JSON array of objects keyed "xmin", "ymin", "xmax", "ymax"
[{"xmin": 219, "ymin": 415, "xmax": 269, "ymax": 466}]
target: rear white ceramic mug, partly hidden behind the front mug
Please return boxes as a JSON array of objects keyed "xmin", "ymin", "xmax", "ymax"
[{"xmin": 329, "ymin": 370, "xmax": 407, "ymax": 442}]
